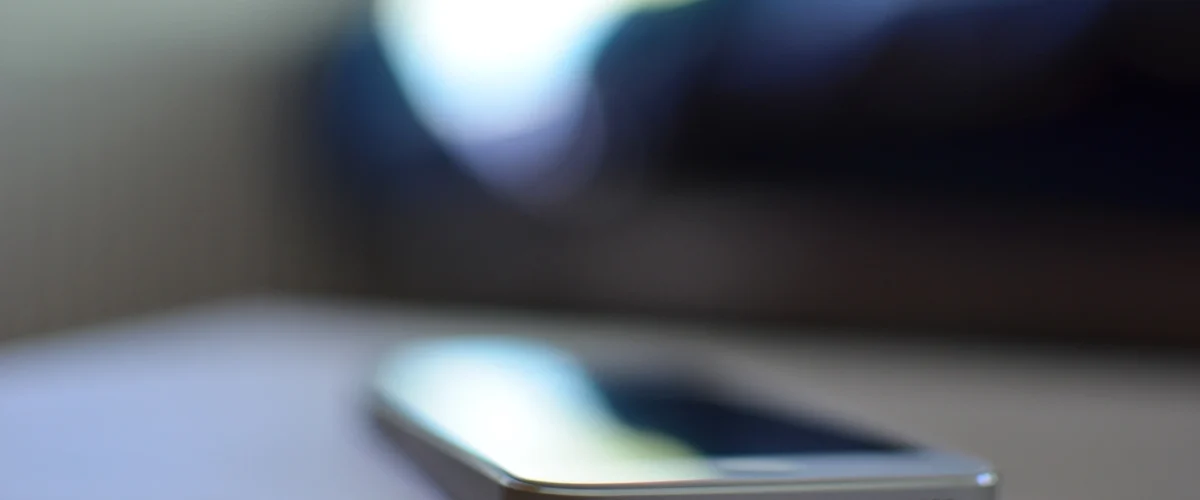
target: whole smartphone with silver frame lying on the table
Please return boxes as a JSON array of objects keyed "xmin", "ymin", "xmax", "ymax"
[{"xmin": 374, "ymin": 338, "xmax": 998, "ymax": 500}]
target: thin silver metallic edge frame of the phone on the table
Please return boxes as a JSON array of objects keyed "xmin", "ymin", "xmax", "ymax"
[{"xmin": 372, "ymin": 391, "xmax": 997, "ymax": 500}]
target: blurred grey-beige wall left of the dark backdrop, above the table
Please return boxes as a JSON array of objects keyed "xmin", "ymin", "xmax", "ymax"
[{"xmin": 0, "ymin": 0, "xmax": 353, "ymax": 337}]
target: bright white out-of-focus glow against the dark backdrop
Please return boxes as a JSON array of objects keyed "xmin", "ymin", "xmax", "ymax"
[{"xmin": 378, "ymin": 0, "xmax": 626, "ymax": 202}]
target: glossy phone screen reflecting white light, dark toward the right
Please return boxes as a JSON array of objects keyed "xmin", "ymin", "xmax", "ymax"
[{"xmin": 379, "ymin": 338, "xmax": 910, "ymax": 484}]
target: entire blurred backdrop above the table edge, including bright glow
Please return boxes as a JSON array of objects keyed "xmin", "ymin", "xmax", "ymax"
[{"xmin": 0, "ymin": 0, "xmax": 1200, "ymax": 347}]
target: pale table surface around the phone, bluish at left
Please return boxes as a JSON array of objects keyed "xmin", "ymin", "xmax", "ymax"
[{"xmin": 0, "ymin": 297, "xmax": 1200, "ymax": 500}]
